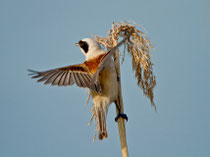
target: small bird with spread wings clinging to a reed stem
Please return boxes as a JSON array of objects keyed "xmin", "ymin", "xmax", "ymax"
[{"xmin": 28, "ymin": 35, "xmax": 129, "ymax": 140}]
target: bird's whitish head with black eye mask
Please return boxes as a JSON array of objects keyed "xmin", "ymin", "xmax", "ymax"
[{"xmin": 75, "ymin": 38, "xmax": 105, "ymax": 60}]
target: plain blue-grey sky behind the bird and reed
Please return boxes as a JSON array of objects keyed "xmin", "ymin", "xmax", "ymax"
[{"xmin": 0, "ymin": 0, "xmax": 210, "ymax": 157}]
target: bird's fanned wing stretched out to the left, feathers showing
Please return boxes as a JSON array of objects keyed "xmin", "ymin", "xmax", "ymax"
[{"xmin": 28, "ymin": 64, "xmax": 101, "ymax": 93}]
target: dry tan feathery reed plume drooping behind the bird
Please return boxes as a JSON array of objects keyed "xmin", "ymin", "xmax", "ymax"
[{"xmin": 89, "ymin": 22, "xmax": 156, "ymax": 139}]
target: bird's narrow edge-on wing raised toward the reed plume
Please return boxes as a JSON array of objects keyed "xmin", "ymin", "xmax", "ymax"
[{"xmin": 91, "ymin": 31, "xmax": 132, "ymax": 85}]
